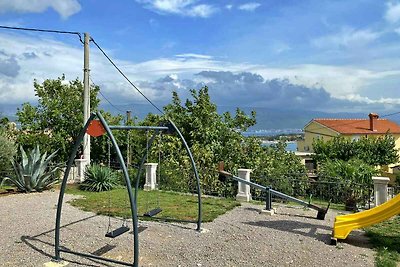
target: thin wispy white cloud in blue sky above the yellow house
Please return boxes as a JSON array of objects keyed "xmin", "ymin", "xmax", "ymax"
[{"xmin": 311, "ymin": 27, "xmax": 381, "ymax": 48}]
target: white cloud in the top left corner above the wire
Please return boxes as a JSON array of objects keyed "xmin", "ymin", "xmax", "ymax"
[{"xmin": 0, "ymin": 0, "xmax": 81, "ymax": 18}]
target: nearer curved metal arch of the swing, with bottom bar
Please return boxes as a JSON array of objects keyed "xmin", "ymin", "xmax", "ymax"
[{"xmin": 55, "ymin": 112, "xmax": 139, "ymax": 267}]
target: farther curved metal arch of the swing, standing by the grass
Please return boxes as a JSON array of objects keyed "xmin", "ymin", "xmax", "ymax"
[{"xmin": 135, "ymin": 119, "xmax": 202, "ymax": 231}]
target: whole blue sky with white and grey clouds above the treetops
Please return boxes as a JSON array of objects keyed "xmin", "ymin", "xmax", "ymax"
[{"xmin": 0, "ymin": 0, "xmax": 400, "ymax": 115}]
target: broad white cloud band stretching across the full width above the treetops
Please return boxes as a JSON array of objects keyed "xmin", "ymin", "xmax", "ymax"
[{"xmin": 0, "ymin": 33, "xmax": 400, "ymax": 111}]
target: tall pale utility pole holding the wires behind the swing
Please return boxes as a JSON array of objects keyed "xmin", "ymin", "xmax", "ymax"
[{"xmin": 83, "ymin": 32, "xmax": 90, "ymax": 164}]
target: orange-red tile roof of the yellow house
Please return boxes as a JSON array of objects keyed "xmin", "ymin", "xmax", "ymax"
[{"xmin": 313, "ymin": 119, "xmax": 400, "ymax": 134}]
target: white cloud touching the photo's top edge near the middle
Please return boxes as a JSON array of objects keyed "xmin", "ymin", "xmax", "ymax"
[{"xmin": 136, "ymin": 0, "xmax": 218, "ymax": 18}]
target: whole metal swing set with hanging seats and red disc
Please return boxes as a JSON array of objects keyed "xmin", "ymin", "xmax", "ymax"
[{"xmin": 54, "ymin": 112, "xmax": 202, "ymax": 267}]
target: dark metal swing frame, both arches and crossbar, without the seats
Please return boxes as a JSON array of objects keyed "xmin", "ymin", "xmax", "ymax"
[{"xmin": 54, "ymin": 112, "xmax": 202, "ymax": 267}]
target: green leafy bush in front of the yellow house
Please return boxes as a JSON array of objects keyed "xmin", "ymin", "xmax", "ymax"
[{"xmin": 313, "ymin": 134, "xmax": 398, "ymax": 166}]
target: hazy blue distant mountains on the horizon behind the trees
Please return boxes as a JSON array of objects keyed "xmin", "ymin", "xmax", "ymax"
[{"xmin": 0, "ymin": 101, "xmax": 400, "ymax": 135}]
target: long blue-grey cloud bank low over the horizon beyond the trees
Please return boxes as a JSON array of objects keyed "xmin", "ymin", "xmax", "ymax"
[{"xmin": 129, "ymin": 71, "xmax": 365, "ymax": 111}]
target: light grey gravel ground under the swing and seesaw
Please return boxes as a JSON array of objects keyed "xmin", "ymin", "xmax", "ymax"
[{"xmin": 0, "ymin": 191, "xmax": 374, "ymax": 267}]
